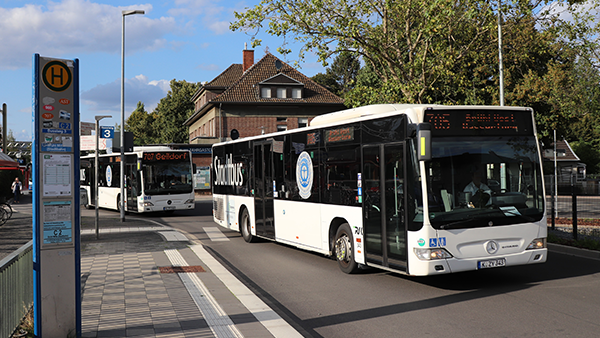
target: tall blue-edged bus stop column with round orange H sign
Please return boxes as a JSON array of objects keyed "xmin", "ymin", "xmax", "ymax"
[{"xmin": 31, "ymin": 54, "xmax": 81, "ymax": 337}]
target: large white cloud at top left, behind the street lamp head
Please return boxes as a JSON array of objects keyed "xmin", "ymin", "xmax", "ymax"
[{"xmin": 0, "ymin": 0, "xmax": 179, "ymax": 69}]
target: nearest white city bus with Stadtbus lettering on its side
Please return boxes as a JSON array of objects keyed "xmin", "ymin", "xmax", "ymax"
[{"xmin": 212, "ymin": 105, "xmax": 547, "ymax": 276}]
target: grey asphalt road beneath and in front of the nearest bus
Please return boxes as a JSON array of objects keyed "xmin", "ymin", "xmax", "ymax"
[{"xmin": 160, "ymin": 200, "xmax": 600, "ymax": 337}]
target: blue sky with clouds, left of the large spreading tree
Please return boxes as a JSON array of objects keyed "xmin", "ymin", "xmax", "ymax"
[{"xmin": 0, "ymin": 0, "xmax": 324, "ymax": 141}]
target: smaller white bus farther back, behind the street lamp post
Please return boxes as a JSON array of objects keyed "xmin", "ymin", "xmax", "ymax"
[{"xmin": 80, "ymin": 147, "xmax": 194, "ymax": 212}]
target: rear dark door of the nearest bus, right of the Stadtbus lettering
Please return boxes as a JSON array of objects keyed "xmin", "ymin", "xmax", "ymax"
[{"xmin": 254, "ymin": 141, "xmax": 275, "ymax": 238}]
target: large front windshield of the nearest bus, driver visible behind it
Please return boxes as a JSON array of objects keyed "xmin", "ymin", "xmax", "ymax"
[{"xmin": 426, "ymin": 136, "xmax": 545, "ymax": 229}]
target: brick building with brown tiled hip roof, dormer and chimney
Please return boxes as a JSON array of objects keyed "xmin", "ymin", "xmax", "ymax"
[{"xmin": 184, "ymin": 50, "xmax": 346, "ymax": 167}]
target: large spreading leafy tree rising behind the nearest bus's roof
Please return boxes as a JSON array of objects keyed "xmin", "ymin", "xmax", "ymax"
[{"xmin": 231, "ymin": 0, "xmax": 506, "ymax": 103}]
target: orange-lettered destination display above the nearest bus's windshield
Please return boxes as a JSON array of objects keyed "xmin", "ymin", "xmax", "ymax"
[{"xmin": 425, "ymin": 110, "xmax": 531, "ymax": 136}]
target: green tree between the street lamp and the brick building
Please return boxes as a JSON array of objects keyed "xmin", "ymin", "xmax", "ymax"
[{"xmin": 152, "ymin": 79, "xmax": 199, "ymax": 143}]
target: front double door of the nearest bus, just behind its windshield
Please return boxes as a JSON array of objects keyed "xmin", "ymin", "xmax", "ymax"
[{"xmin": 362, "ymin": 143, "xmax": 407, "ymax": 270}]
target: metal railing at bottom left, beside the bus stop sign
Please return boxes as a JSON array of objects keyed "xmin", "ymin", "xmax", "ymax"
[{"xmin": 0, "ymin": 241, "xmax": 33, "ymax": 338}]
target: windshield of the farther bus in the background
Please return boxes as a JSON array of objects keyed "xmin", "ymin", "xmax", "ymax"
[{"xmin": 143, "ymin": 158, "xmax": 193, "ymax": 195}]
